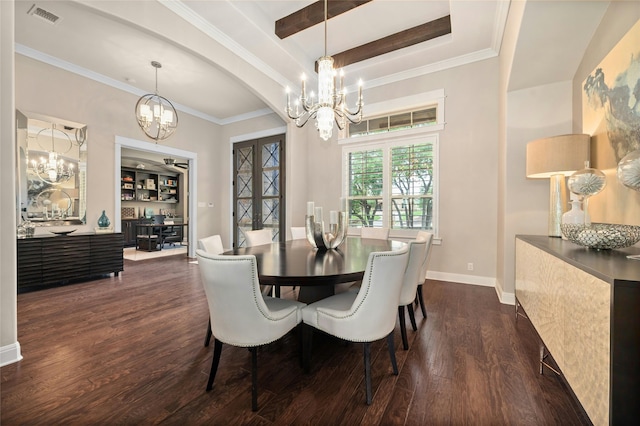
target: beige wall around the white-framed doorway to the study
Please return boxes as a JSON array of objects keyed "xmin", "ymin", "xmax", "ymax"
[{"xmin": 15, "ymin": 55, "xmax": 221, "ymax": 235}]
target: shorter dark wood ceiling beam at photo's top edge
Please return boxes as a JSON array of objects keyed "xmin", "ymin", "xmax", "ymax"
[{"xmin": 276, "ymin": 0, "xmax": 371, "ymax": 39}]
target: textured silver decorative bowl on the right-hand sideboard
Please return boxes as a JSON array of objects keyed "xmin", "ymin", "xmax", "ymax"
[{"xmin": 560, "ymin": 223, "xmax": 640, "ymax": 250}]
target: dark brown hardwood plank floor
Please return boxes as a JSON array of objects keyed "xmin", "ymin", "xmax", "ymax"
[{"xmin": 0, "ymin": 255, "xmax": 588, "ymax": 426}]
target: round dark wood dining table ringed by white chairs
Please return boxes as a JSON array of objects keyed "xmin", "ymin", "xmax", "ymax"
[{"xmin": 224, "ymin": 237, "xmax": 405, "ymax": 303}]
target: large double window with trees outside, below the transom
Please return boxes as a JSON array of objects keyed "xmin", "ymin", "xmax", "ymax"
[{"xmin": 343, "ymin": 129, "xmax": 438, "ymax": 232}]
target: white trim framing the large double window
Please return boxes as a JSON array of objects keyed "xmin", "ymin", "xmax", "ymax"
[{"xmin": 342, "ymin": 131, "xmax": 441, "ymax": 244}]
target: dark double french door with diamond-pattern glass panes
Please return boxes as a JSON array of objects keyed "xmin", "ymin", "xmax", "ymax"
[{"xmin": 233, "ymin": 135, "xmax": 286, "ymax": 247}]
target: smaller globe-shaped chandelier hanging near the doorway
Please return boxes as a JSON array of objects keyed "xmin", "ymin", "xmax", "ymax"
[{"xmin": 136, "ymin": 61, "xmax": 178, "ymax": 142}]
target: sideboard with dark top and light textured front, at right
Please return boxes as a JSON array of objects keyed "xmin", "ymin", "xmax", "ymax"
[{"xmin": 515, "ymin": 235, "xmax": 640, "ymax": 425}]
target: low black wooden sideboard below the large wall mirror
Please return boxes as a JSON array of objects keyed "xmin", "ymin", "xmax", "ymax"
[{"xmin": 17, "ymin": 232, "xmax": 124, "ymax": 292}]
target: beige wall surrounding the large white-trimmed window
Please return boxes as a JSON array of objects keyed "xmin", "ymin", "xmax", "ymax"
[{"xmin": 298, "ymin": 58, "xmax": 498, "ymax": 285}]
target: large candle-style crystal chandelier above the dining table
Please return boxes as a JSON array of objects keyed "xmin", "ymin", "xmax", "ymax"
[{"xmin": 285, "ymin": 0, "xmax": 363, "ymax": 141}]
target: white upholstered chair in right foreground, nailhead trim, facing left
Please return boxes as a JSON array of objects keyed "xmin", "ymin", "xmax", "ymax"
[{"xmin": 302, "ymin": 247, "xmax": 409, "ymax": 405}]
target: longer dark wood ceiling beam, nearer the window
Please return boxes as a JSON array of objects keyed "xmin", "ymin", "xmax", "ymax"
[{"xmin": 328, "ymin": 15, "xmax": 451, "ymax": 70}]
